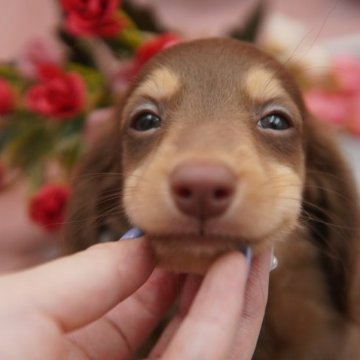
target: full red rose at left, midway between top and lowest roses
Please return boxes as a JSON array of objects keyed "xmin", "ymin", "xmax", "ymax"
[{"xmin": 26, "ymin": 65, "xmax": 85, "ymax": 119}]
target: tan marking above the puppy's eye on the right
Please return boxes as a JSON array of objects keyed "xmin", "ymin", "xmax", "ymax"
[{"xmin": 244, "ymin": 67, "xmax": 288, "ymax": 101}]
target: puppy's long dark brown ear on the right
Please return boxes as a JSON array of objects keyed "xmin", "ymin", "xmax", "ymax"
[{"xmin": 303, "ymin": 120, "xmax": 360, "ymax": 320}]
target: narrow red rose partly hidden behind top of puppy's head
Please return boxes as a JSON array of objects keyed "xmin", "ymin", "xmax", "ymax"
[{"xmin": 135, "ymin": 34, "xmax": 180, "ymax": 66}]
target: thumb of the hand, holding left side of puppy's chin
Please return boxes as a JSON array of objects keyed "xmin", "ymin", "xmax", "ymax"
[{"xmin": 0, "ymin": 238, "xmax": 154, "ymax": 332}]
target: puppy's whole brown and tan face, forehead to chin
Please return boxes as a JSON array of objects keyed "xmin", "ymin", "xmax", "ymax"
[{"xmin": 120, "ymin": 40, "xmax": 304, "ymax": 272}]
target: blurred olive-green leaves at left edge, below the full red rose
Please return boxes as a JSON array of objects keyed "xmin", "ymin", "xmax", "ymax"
[{"xmin": 0, "ymin": 112, "xmax": 85, "ymax": 183}]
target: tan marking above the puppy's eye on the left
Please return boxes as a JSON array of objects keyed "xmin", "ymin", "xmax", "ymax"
[{"xmin": 133, "ymin": 67, "xmax": 180, "ymax": 99}]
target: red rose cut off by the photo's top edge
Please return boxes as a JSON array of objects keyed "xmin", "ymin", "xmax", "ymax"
[{"xmin": 61, "ymin": 0, "xmax": 123, "ymax": 37}]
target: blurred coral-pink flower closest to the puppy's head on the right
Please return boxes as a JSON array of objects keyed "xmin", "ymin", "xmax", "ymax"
[{"xmin": 305, "ymin": 89, "xmax": 349, "ymax": 125}]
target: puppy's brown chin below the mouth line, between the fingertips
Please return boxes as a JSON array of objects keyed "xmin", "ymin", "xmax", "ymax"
[{"xmin": 148, "ymin": 236, "xmax": 243, "ymax": 275}]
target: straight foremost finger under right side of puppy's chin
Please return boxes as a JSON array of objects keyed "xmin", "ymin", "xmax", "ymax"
[{"xmin": 163, "ymin": 252, "xmax": 248, "ymax": 360}]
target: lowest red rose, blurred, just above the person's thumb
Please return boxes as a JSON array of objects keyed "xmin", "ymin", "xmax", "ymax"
[{"xmin": 29, "ymin": 184, "xmax": 69, "ymax": 231}]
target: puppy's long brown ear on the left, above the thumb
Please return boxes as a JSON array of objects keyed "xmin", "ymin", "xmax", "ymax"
[{"xmin": 64, "ymin": 122, "xmax": 128, "ymax": 253}]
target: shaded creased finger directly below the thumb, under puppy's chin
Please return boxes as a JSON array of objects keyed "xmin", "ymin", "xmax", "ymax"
[{"xmin": 68, "ymin": 269, "xmax": 180, "ymax": 359}]
